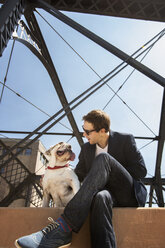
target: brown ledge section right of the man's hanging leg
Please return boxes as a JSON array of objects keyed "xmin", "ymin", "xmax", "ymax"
[{"xmin": 113, "ymin": 208, "xmax": 165, "ymax": 248}]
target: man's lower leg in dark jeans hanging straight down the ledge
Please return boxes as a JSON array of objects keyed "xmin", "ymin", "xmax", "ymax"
[{"xmin": 90, "ymin": 190, "xmax": 116, "ymax": 248}]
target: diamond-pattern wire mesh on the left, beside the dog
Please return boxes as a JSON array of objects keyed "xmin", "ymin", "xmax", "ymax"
[{"xmin": 0, "ymin": 142, "xmax": 42, "ymax": 207}]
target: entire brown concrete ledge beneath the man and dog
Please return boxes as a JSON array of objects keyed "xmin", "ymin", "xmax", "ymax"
[{"xmin": 0, "ymin": 208, "xmax": 165, "ymax": 248}]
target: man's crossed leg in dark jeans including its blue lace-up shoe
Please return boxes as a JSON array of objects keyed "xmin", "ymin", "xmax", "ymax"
[{"xmin": 14, "ymin": 153, "xmax": 135, "ymax": 248}]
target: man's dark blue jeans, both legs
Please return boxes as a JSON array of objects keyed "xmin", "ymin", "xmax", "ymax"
[{"xmin": 62, "ymin": 153, "xmax": 138, "ymax": 248}]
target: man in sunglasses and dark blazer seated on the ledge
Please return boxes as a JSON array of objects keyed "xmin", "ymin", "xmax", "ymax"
[{"xmin": 16, "ymin": 110, "xmax": 147, "ymax": 248}]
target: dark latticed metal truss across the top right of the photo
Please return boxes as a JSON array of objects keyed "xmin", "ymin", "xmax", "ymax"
[{"xmin": 25, "ymin": 0, "xmax": 165, "ymax": 21}]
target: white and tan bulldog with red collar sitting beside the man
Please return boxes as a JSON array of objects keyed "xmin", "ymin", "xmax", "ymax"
[{"xmin": 42, "ymin": 142, "xmax": 80, "ymax": 207}]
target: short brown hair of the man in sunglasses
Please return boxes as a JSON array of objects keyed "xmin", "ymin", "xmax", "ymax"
[{"xmin": 82, "ymin": 110, "xmax": 110, "ymax": 132}]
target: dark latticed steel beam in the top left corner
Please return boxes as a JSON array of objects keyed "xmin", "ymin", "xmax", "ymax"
[{"xmin": 0, "ymin": 0, "xmax": 25, "ymax": 56}]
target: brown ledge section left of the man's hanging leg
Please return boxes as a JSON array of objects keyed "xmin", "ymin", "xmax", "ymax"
[{"xmin": 0, "ymin": 208, "xmax": 90, "ymax": 248}]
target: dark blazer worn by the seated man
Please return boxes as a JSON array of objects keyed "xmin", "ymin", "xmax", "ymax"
[{"xmin": 75, "ymin": 131, "xmax": 147, "ymax": 206}]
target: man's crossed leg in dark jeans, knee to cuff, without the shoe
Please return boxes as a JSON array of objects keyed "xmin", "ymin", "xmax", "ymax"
[{"xmin": 62, "ymin": 153, "xmax": 137, "ymax": 232}]
